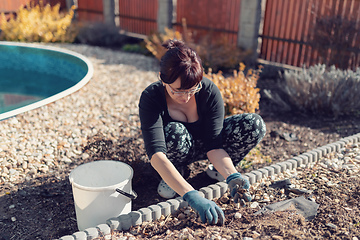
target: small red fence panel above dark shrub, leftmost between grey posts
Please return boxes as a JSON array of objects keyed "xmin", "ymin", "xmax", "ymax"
[{"xmin": 77, "ymin": 0, "xmax": 104, "ymax": 22}]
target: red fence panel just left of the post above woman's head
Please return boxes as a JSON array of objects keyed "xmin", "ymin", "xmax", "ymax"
[{"xmin": 119, "ymin": 0, "xmax": 158, "ymax": 35}]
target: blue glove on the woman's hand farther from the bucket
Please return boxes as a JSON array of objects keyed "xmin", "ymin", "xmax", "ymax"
[{"xmin": 226, "ymin": 173, "xmax": 252, "ymax": 203}]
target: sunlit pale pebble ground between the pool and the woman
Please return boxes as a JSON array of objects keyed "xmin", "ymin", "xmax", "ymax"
[{"xmin": 0, "ymin": 44, "xmax": 159, "ymax": 184}]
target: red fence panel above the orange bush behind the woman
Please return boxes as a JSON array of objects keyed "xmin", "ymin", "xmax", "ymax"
[{"xmin": 175, "ymin": 0, "xmax": 241, "ymax": 44}]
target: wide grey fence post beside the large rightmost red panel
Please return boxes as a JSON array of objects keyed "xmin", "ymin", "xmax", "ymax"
[{"xmin": 237, "ymin": 0, "xmax": 261, "ymax": 60}]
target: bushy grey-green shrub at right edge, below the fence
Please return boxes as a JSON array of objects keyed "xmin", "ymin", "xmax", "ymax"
[{"xmin": 264, "ymin": 64, "xmax": 360, "ymax": 118}]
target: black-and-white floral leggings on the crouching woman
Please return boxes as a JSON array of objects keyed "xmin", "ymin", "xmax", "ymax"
[{"xmin": 164, "ymin": 113, "xmax": 266, "ymax": 173}]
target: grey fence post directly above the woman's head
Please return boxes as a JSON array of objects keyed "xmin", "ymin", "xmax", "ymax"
[{"xmin": 157, "ymin": 0, "xmax": 173, "ymax": 33}]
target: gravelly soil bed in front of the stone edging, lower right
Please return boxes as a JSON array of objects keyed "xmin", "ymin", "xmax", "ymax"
[{"xmin": 112, "ymin": 144, "xmax": 360, "ymax": 240}]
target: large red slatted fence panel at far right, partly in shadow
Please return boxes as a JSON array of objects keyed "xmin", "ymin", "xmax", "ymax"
[{"xmin": 260, "ymin": 0, "xmax": 360, "ymax": 69}]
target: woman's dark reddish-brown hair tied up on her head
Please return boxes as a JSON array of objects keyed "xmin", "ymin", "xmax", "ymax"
[{"xmin": 160, "ymin": 39, "xmax": 203, "ymax": 89}]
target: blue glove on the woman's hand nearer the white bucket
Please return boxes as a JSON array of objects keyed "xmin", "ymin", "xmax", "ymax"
[{"xmin": 183, "ymin": 190, "xmax": 225, "ymax": 225}]
